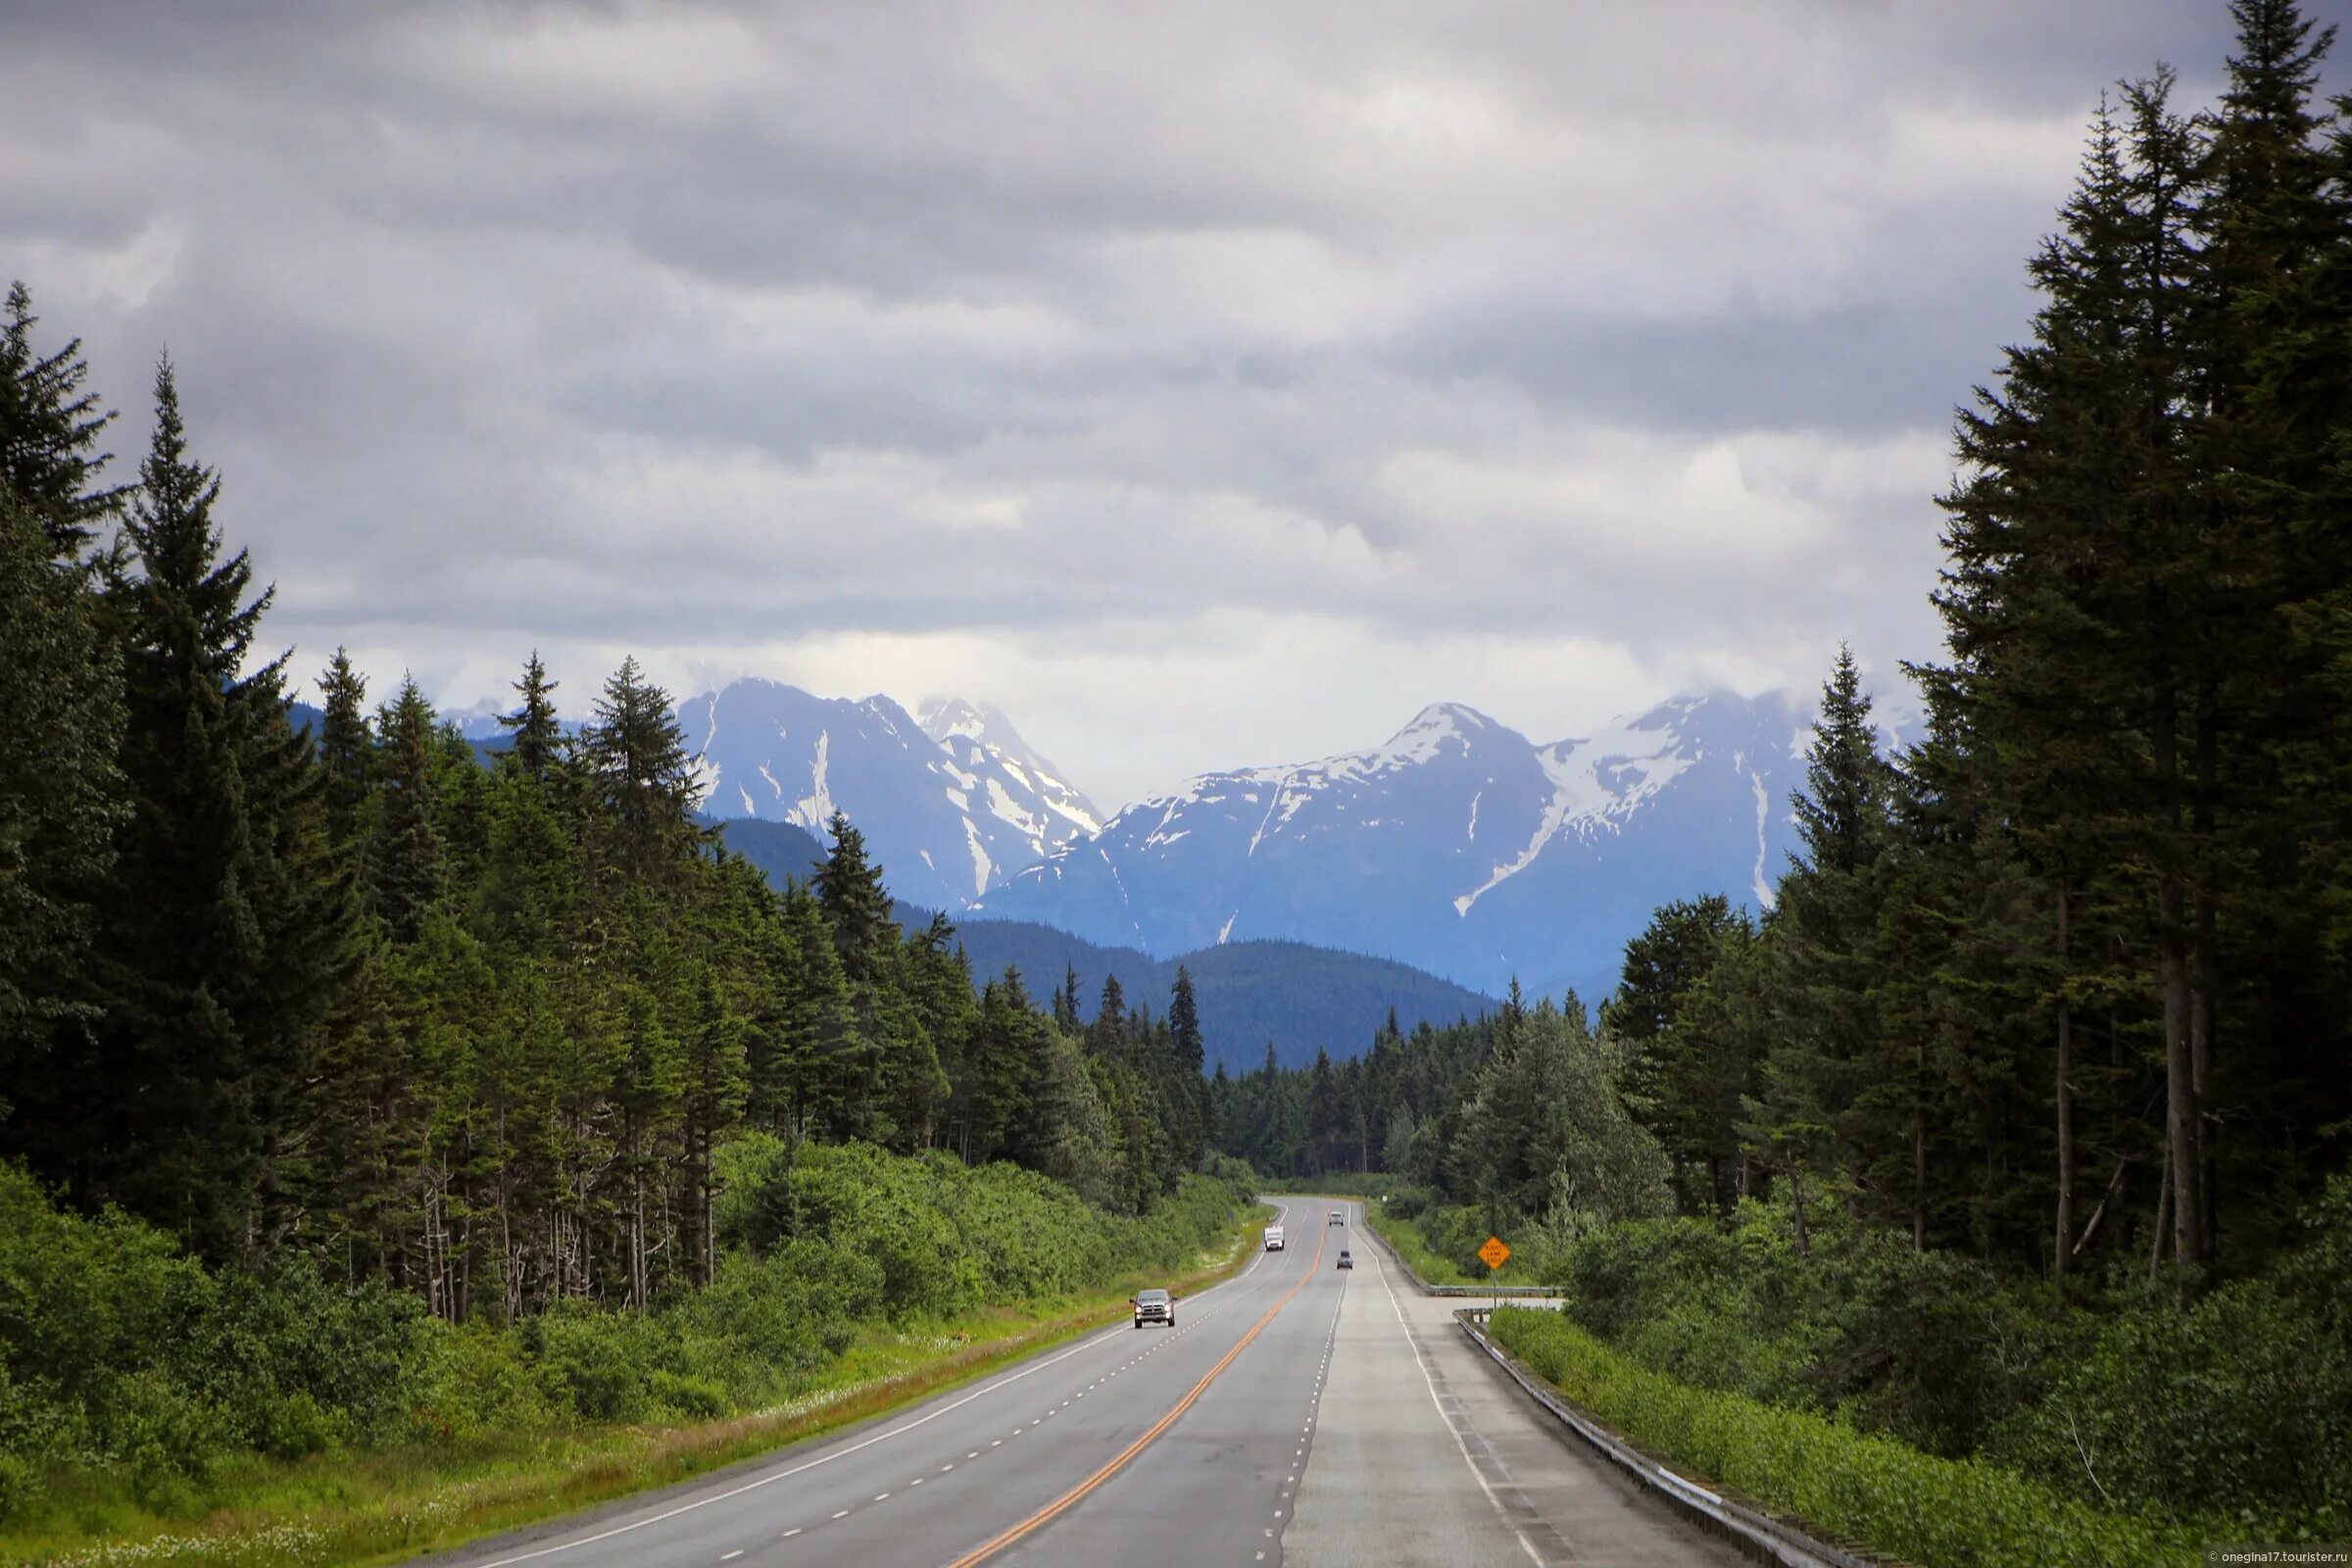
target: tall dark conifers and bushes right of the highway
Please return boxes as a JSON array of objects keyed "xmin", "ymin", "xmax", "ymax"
[{"xmin": 1211, "ymin": 0, "xmax": 2352, "ymax": 1561}]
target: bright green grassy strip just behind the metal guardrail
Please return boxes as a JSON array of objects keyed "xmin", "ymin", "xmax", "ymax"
[{"xmin": 1494, "ymin": 1307, "xmax": 2209, "ymax": 1568}]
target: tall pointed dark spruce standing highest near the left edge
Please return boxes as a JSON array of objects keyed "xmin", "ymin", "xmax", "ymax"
[{"xmin": 77, "ymin": 362, "xmax": 351, "ymax": 1257}]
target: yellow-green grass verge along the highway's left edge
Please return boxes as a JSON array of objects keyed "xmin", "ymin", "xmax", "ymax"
[{"xmin": 0, "ymin": 1203, "xmax": 1275, "ymax": 1568}]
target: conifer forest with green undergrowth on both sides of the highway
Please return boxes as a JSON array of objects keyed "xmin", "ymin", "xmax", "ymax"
[{"xmin": 0, "ymin": 0, "xmax": 2352, "ymax": 1563}]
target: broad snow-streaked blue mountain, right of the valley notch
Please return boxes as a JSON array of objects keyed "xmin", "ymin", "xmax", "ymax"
[{"xmin": 966, "ymin": 696, "xmax": 1811, "ymax": 995}]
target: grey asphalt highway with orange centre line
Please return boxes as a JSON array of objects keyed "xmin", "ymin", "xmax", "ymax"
[{"xmin": 423, "ymin": 1199, "xmax": 1742, "ymax": 1568}]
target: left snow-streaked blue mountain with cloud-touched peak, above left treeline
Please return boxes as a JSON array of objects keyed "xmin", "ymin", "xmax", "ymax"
[{"xmin": 677, "ymin": 679, "xmax": 1099, "ymax": 909}]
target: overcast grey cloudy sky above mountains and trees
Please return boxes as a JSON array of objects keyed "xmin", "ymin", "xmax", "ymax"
[{"xmin": 0, "ymin": 0, "xmax": 2248, "ymax": 807}]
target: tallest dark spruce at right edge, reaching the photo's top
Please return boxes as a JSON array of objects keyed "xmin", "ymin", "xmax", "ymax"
[{"xmin": 2189, "ymin": 0, "xmax": 2352, "ymax": 1260}]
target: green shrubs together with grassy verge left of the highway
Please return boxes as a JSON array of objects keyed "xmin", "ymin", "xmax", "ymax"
[{"xmin": 0, "ymin": 1140, "xmax": 1270, "ymax": 1568}]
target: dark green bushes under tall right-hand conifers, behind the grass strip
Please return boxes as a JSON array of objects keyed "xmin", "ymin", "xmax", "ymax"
[{"xmin": 1552, "ymin": 1178, "xmax": 2352, "ymax": 1544}]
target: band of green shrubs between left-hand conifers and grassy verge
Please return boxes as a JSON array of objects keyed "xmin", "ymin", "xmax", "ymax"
[{"xmin": 0, "ymin": 1136, "xmax": 1251, "ymax": 1519}]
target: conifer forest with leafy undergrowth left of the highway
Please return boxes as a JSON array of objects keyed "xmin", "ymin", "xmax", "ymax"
[{"xmin": 0, "ymin": 284, "xmax": 1247, "ymax": 1542}]
